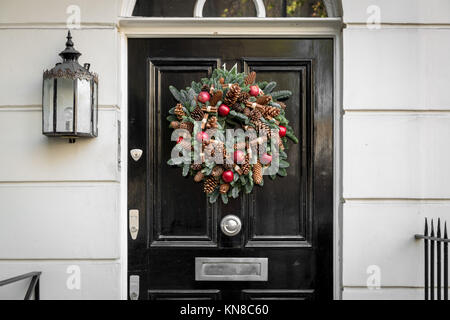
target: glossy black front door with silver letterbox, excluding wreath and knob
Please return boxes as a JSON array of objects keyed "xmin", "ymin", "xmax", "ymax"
[{"xmin": 128, "ymin": 38, "xmax": 333, "ymax": 299}]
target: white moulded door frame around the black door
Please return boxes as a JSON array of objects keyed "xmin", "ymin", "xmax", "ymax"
[{"xmin": 118, "ymin": 17, "xmax": 344, "ymax": 300}]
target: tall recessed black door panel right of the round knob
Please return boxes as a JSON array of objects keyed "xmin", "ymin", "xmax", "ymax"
[{"xmin": 244, "ymin": 58, "xmax": 313, "ymax": 247}]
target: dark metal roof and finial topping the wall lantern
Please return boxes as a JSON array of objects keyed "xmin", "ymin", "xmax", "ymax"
[{"xmin": 44, "ymin": 30, "xmax": 98, "ymax": 82}]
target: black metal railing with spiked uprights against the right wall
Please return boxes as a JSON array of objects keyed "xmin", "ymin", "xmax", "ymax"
[{"xmin": 415, "ymin": 218, "xmax": 450, "ymax": 300}]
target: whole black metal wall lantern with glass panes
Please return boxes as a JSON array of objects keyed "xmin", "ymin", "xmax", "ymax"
[{"xmin": 42, "ymin": 30, "xmax": 98, "ymax": 143}]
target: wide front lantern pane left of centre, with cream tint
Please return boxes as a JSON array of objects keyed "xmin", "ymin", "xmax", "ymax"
[{"xmin": 56, "ymin": 78, "xmax": 74, "ymax": 132}]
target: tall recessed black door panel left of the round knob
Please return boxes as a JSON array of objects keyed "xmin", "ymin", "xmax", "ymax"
[{"xmin": 148, "ymin": 57, "xmax": 220, "ymax": 247}]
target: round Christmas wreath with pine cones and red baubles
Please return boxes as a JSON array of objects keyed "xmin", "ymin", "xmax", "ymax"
[{"xmin": 167, "ymin": 65, "xmax": 298, "ymax": 204}]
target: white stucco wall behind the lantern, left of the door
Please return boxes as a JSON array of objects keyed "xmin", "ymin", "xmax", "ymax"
[{"xmin": 0, "ymin": 0, "xmax": 124, "ymax": 299}]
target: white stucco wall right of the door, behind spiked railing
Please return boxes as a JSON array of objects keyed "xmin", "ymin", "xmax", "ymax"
[{"xmin": 343, "ymin": 0, "xmax": 450, "ymax": 299}]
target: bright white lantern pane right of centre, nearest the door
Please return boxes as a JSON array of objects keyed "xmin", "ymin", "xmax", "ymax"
[{"xmin": 77, "ymin": 79, "xmax": 92, "ymax": 134}]
